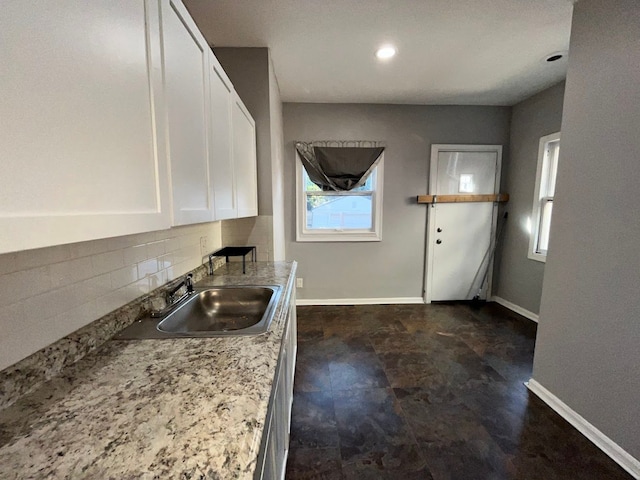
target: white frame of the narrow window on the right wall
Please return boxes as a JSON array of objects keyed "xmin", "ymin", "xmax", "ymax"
[{"xmin": 527, "ymin": 132, "xmax": 560, "ymax": 263}]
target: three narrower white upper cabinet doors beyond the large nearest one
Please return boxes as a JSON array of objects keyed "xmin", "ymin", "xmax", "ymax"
[{"xmin": 161, "ymin": 0, "xmax": 258, "ymax": 225}]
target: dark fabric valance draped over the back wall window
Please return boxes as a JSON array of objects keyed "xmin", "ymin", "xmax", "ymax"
[{"xmin": 296, "ymin": 141, "xmax": 384, "ymax": 192}]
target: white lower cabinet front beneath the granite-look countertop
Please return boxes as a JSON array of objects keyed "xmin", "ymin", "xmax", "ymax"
[{"xmin": 256, "ymin": 290, "xmax": 297, "ymax": 480}]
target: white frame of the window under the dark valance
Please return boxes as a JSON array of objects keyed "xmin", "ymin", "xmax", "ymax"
[{"xmin": 296, "ymin": 152, "xmax": 384, "ymax": 242}]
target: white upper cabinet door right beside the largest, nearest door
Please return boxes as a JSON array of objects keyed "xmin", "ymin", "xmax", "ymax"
[{"xmin": 161, "ymin": 0, "xmax": 213, "ymax": 225}]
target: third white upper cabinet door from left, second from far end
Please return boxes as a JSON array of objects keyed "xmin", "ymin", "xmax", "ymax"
[{"xmin": 209, "ymin": 52, "xmax": 238, "ymax": 220}]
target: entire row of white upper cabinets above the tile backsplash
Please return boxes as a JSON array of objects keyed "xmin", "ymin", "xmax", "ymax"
[{"xmin": 0, "ymin": 0, "xmax": 257, "ymax": 254}]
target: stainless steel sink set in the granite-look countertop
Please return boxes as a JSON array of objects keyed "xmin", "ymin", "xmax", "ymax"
[{"xmin": 114, "ymin": 285, "xmax": 281, "ymax": 339}]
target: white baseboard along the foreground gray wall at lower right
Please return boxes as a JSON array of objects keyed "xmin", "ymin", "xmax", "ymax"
[{"xmin": 525, "ymin": 378, "xmax": 640, "ymax": 479}]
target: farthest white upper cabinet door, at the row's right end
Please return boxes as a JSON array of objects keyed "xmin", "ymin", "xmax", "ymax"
[{"xmin": 232, "ymin": 92, "xmax": 258, "ymax": 217}]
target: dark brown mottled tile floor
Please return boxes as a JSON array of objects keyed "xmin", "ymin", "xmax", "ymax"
[{"xmin": 286, "ymin": 303, "xmax": 631, "ymax": 480}]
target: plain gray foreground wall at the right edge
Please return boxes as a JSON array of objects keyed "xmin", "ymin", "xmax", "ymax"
[{"xmin": 533, "ymin": 0, "xmax": 640, "ymax": 459}]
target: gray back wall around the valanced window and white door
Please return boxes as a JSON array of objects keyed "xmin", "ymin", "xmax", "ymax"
[{"xmin": 284, "ymin": 103, "xmax": 511, "ymax": 299}]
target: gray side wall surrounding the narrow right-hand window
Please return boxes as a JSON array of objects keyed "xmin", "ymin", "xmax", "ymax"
[{"xmin": 493, "ymin": 82, "xmax": 564, "ymax": 313}]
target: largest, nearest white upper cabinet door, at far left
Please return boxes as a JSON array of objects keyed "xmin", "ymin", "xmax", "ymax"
[{"xmin": 0, "ymin": 0, "xmax": 170, "ymax": 253}]
